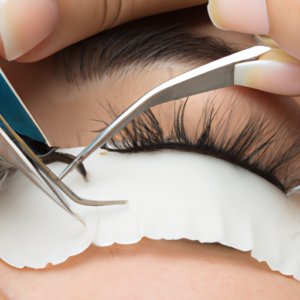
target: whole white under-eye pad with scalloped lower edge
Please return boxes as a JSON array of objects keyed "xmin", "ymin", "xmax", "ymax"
[{"xmin": 0, "ymin": 149, "xmax": 300, "ymax": 280}]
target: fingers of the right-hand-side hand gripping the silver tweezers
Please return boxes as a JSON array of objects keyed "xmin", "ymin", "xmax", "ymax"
[{"xmin": 208, "ymin": 0, "xmax": 300, "ymax": 95}]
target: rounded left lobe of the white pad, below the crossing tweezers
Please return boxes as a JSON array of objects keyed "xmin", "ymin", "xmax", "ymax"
[{"xmin": 0, "ymin": 172, "xmax": 98, "ymax": 269}]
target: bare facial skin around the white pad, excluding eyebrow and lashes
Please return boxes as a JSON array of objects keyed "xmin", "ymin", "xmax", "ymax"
[{"xmin": 0, "ymin": 5, "xmax": 300, "ymax": 300}]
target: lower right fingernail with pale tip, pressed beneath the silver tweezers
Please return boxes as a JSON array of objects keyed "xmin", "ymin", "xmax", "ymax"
[{"xmin": 234, "ymin": 60, "xmax": 300, "ymax": 96}]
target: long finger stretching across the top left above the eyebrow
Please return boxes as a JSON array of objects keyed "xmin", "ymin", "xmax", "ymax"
[{"xmin": 0, "ymin": 0, "xmax": 207, "ymax": 62}]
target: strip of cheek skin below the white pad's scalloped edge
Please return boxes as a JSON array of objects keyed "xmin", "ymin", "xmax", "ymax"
[{"xmin": 0, "ymin": 239, "xmax": 300, "ymax": 300}]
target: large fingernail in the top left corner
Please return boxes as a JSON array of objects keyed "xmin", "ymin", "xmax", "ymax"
[{"xmin": 0, "ymin": 0, "xmax": 59, "ymax": 60}]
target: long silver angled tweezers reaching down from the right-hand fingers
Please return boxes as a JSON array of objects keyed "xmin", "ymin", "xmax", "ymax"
[{"xmin": 59, "ymin": 46, "xmax": 270, "ymax": 179}]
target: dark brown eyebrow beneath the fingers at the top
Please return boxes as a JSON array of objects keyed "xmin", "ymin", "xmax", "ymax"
[{"xmin": 57, "ymin": 9, "xmax": 237, "ymax": 84}]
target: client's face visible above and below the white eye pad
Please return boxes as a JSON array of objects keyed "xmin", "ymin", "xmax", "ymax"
[{"xmin": 0, "ymin": 8, "xmax": 300, "ymax": 299}]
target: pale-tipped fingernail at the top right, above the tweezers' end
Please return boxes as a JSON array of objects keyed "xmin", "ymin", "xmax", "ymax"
[{"xmin": 208, "ymin": 0, "xmax": 269, "ymax": 34}]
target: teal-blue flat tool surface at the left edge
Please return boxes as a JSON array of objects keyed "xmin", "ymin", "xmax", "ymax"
[{"xmin": 0, "ymin": 69, "xmax": 47, "ymax": 144}]
